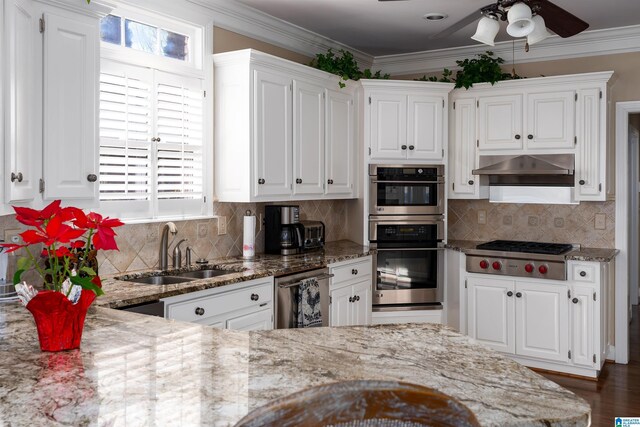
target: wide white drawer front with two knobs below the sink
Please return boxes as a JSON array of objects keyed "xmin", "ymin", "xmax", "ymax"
[{"xmin": 167, "ymin": 283, "xmax": 273, "ymax": 322}]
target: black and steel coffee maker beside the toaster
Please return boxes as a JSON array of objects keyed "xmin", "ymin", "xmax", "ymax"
[{"xmin": 264, "ymin": 205, "xmax": 304, "ymax": 255}]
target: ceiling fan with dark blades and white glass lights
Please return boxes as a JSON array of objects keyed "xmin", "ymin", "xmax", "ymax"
[{"xmin": 378, "ymin": 0, "xmax": 589, "ymax": 46}]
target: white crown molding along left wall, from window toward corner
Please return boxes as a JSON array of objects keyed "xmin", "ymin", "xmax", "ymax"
[{"xmin": 187, "ymin": 0, "xmax": 374, "ymax": 68}]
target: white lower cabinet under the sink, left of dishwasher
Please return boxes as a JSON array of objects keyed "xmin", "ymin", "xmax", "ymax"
[{"xmin": 163, "ymin": 277, "xmax": 273, "ymax": 331}]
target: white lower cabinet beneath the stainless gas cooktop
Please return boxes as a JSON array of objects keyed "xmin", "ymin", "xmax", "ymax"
[{"xmin": 463, "ymin": 261, "xmax": 611, "ymax": 377}]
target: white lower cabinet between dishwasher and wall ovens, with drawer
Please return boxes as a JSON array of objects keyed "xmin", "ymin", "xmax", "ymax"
[{"xmin": 328, "ymin": 256, "xmax": 372, "ymax": 326}]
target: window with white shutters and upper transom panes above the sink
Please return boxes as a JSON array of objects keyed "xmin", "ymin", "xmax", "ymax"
[{"xmin": 99, "ymin": 15, "xmax": 207, "ymax": 219}]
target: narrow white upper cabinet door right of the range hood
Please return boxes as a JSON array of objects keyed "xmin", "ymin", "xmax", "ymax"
[{"xmin": 576, "ymin": 88, "xmax": 606, "ymax": 201}]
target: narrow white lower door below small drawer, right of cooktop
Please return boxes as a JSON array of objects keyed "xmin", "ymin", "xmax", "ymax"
[{"xmin": 569, "ymin": 285, "xmax": 597, "ymax": 367}]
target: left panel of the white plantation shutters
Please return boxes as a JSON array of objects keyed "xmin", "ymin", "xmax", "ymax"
[{"xmin": 100, "ymin": 61, "xmax": 153, "ymax": 216}]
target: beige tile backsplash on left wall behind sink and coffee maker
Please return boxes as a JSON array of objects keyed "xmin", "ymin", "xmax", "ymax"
[{"xmin": 0, "ymin": 200, "xmax": 347, "ymax": 277}]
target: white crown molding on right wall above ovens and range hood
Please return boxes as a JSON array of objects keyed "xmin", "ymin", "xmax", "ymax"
[{"xmin": 373, "ymin": 25, "xmax": 640, "ymax": 76}]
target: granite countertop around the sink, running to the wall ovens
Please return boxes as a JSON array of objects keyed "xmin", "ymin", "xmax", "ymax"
[{"xmin": 96, "ymin": 240, "xmax": 375, "ymax": 308}]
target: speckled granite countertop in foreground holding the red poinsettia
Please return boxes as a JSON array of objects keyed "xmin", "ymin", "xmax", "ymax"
[{"xmin": 0, "ymin": 303, "xmax": 590, "ymax": 426}]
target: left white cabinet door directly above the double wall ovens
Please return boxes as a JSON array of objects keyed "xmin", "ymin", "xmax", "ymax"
[{"xmin": 369, "ymin": 93, "xmax": 407, "ymax": 159}]
